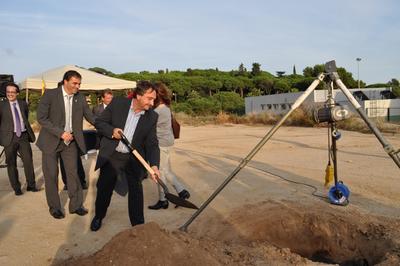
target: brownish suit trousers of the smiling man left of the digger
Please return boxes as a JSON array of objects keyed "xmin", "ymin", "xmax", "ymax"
[{"xmin": 42, "ymin": 141, "xmax": 83, "ymax": 212}]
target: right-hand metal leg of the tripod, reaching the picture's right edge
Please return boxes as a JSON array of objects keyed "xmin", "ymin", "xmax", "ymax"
[{"xmin": 331, "ymin": 75, "xmax": 400, "ymax": 168}]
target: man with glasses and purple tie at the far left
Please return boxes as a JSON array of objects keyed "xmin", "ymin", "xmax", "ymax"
[{"xmin": 0, "ymin": 83, "xmax": 39, "ymax": 196}]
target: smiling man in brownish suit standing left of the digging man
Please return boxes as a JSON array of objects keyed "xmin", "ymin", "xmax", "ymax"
[{"xmin": 36, "ymin": 70, "xmax": 94, "ymax": 219}]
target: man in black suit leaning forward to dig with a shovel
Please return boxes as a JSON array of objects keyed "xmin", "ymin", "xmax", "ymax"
[{"xmin": 90, "ymin": 81, "xmax": 160, "ymax": 231}]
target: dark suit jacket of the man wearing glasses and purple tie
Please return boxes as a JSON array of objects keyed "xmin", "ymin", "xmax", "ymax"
[{"xmin": 0, "ymin": 99, "xmax": 36, "ymax": 146}]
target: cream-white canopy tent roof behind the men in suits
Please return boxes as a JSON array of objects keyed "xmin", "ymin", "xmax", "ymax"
[{"xmin": 20, "ymin": 65, "xmax": 136, "ymax": 99}]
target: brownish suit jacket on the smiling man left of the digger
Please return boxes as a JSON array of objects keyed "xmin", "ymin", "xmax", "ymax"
[{"xmin": 36, "ymin": 87, "xmax": 94, "ymax": 154}]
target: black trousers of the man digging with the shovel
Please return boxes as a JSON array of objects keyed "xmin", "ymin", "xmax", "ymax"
[{"xmin": 95, "ymin": 152, "xmax": 144, "ymax": 226}]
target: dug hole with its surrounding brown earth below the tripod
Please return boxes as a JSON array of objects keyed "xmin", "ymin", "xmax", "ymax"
[{"xmin": 194, "ymin": 201, "xmax": 400, "ymax": 265}]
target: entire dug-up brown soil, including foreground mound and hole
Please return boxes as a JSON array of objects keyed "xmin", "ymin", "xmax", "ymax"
[{"xmin": 61, "ymin": 201, "xmax": 400, "ymax": 265}]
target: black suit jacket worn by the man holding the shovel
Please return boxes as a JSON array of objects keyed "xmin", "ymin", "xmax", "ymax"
[{"xmin": 95, "ymin": 97, "xmax": 160, "ymax": 177}]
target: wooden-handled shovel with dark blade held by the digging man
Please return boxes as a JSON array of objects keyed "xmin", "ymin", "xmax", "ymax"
[{"xmin": 120, "ymin": 132, "xmax": 198, "ymax": 209}]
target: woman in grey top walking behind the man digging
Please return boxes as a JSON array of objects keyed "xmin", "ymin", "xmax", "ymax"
[{"xmin": 148, "ymin": 83, "xmax": 190, "ymax": 210}]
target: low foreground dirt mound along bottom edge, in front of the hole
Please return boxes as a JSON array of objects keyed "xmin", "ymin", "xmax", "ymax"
[{"xmin": 60, "ymin": 223, "xmax": 307, "ymax": 266}]
